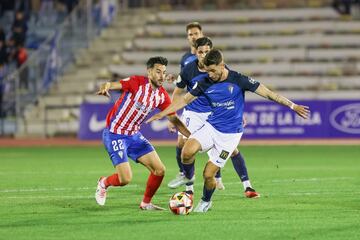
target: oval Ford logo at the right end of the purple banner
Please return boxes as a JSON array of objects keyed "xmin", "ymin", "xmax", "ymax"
[{"xmin": 330, "ymin": 103, "xmax": 360, "ymax": 134}]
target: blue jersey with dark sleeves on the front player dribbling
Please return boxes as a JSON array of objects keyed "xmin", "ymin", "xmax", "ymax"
[{"xmin": 190, "ymin": 70, "xmax": 260, "ymax": 133}]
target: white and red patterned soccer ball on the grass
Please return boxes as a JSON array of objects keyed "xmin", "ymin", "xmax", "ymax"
[{"xmin": 169, "ymin": 192, "xmax": 193, "ymax": 215}]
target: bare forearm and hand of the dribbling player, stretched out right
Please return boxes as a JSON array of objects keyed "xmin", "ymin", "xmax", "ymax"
[{"xmin": 255, "ymin": 84, "xmax": 310, "ymax": 119}]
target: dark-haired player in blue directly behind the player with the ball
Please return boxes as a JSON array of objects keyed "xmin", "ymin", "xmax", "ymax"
[{"xmin": 168, "ymin": 37, "xmax": 260, "ymax": 198}]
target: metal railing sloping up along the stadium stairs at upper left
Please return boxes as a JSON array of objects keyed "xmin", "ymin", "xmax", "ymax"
[{"xmin": 0, "ymin": 0, "xmax": 117, "ymax": 135}]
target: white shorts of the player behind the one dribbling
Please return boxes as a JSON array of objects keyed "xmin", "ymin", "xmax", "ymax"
[{"xmin": 178, "ymin": 109, "xmax": 210, "ymax": 136}]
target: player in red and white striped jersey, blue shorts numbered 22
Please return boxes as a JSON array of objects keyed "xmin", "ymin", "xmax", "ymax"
[{"xmin": 95, "ymin": 57, "xmax": 190, "ymax": 210}]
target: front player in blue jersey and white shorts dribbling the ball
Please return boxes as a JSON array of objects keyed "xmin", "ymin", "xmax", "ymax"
[{"xmin": 147, "ymin": 49, "xmax": 310, "ymax": 212}]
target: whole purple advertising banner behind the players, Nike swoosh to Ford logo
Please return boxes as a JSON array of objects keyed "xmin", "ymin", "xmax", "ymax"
[{"xmin": 78, "ymin": 100, "xmax": 360, "ymax": 140}]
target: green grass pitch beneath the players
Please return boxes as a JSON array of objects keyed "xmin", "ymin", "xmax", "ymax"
[{"xmin": 0, "ymin": 146, "xmax": 360, "ymax": 240}]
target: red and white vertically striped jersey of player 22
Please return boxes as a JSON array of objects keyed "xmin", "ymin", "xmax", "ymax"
[{"xmin": 106, "ymin": 76, "xmax": 171, "ymax": 135}]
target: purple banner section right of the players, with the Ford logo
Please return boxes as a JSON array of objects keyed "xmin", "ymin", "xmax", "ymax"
[{"xmin": 243, "ymin": 100, "xmax": 360, "ymax": 139}]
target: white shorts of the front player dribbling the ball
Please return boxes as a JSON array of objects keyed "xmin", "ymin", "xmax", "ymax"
[{"xmin": 189, "ymin": 122, "xmax": 243, "ymax": 168}]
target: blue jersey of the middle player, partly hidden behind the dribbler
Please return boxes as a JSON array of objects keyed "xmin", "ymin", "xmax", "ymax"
[{"xmin": 176, "ymin": 59, "xmax": 212, "ymax": 112}]
